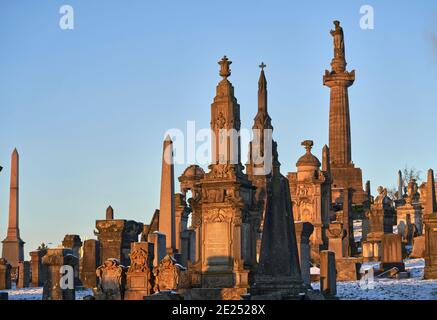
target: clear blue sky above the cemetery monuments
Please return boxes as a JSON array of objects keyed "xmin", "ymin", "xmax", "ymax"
[{"xmin": 0, "ymin": 0, "xmax": 437, "ymax": 257}]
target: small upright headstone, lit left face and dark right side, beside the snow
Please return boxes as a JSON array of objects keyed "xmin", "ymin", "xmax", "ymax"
[{"xmin": 320, "ymin": 251, "xmax": 337, "ymax": 296}]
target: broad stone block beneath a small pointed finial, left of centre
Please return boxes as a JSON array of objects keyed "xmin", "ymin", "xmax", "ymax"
[{"xmin": 96, "ymin": 220, "xmax": 143, "ymax": 266}]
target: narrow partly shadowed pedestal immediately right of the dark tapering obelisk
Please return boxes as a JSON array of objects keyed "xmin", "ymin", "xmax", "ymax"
[{"xmin": 294, "ymin": 222, "xmax": 314, "ymax": 286}]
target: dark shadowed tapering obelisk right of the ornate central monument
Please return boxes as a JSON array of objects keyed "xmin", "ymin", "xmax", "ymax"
[{"xmin": 250, "ymin": 154, "xmax": 305, "ymax": 300}]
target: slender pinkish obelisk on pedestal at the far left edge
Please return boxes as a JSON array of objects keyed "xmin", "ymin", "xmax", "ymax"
[{"xmin": 2, "ymin": 149, "xmax": 24, "ymax": 268}]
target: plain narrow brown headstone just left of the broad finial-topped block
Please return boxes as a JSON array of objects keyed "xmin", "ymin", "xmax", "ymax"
[{"xmin": 80, "ymin": 239, "xmax": 101, "ymax": 288}]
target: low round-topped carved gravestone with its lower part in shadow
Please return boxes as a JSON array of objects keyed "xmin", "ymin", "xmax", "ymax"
[{"xmin": 94, "ymin": 258, "xmax": 126, "ymax": 300}]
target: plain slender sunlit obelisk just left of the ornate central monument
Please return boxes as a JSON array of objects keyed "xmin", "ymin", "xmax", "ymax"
[{"xmin": 159, "ymin": 136, "xmax": 176, "ymax": 254}]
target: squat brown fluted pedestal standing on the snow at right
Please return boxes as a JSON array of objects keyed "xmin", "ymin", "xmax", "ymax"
[{"xmin": 381, "ymin": 234, "xmax": 405, "ymax": 272}]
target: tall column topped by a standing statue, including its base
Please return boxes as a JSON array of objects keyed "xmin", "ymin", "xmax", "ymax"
[{"xmin": 323, "ymin": 21, "xmax": 367, "ymax": 204}]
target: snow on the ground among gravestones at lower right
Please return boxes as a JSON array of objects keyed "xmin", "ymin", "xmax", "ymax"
[{"xmin": 312, "ymin": 259, "xmax": 437, "ymax": 300}]
